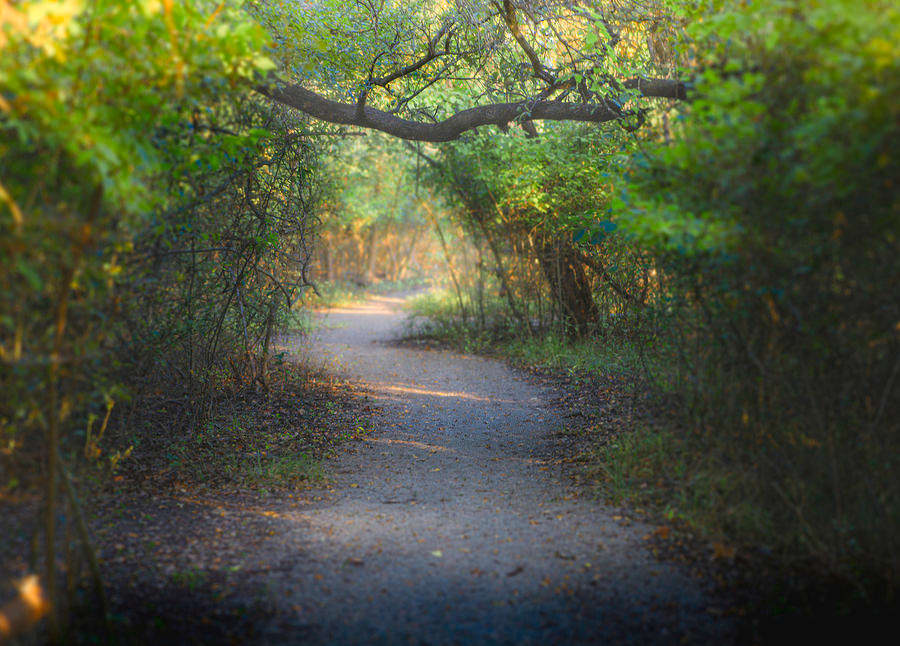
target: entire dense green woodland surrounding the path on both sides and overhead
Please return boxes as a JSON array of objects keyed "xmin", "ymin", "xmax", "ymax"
[{"xmin": 0, "ymin": 0, "xmax": 900, "ymax": 635}]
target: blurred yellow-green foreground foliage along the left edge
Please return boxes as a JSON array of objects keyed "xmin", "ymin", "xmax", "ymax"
[{"xmin": 0, "ymin": 0, "xmax": 278, "ymax": 476}]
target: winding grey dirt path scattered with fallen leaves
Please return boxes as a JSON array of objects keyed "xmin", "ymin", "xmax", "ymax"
[{"xmin": 262, "ymin": 297, "xmax": 727, "ymax": 644}]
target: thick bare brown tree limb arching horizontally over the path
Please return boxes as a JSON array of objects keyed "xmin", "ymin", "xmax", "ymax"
[{"xmin": 257, "ymin": 79, "xmax": 686, "ymax": 142}]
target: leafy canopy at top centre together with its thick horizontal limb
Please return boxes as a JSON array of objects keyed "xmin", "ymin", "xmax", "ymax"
[{"xmin": 253, "ymin": 0, "xmax": 689, "ymax": 141}]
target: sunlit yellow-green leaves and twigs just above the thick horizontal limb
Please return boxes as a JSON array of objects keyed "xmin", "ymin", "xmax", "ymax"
[{"xmin": 251, "ymin": 0, "xmax": 679, "ymax": 132}]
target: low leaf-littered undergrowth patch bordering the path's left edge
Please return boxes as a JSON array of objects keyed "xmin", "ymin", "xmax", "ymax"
[{"xmin": 111, "ymin": 364, "xmax": 367, "ymax": 490}]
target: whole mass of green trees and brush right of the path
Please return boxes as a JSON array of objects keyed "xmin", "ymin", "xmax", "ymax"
[{"xmin": 404, "ymin": 0, "xmax": 900, "ymax": 592}]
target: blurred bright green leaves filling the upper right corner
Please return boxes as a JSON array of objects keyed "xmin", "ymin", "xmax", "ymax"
[{"xmin": 621, "ymin": 0, "xmax": 900, "ymax": 256}]
